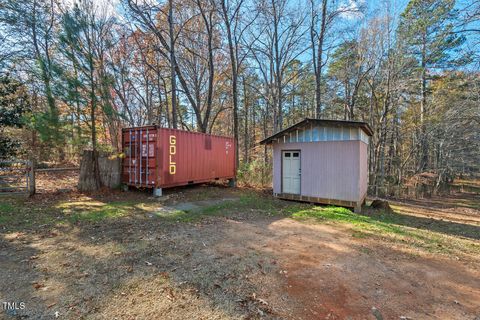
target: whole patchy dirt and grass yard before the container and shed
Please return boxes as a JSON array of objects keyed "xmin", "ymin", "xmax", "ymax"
[{"xmin": 0, "ymin": 187, "xmax": 480, "ymax": 320}]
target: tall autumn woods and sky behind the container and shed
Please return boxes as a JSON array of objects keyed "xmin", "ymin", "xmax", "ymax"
[{"xmin": 0, "ymin": 0, "xmax": 480, "ymax": 193}]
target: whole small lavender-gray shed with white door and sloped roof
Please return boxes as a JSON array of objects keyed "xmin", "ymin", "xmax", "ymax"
[{"xmin": 261, "ymin": 118, "xmax": 373, "ymax": 212}]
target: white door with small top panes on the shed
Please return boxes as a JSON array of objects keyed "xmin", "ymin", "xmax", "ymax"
[{"xmin": 282, "ymin": 151, "xmax": 301, "ymax": 194}]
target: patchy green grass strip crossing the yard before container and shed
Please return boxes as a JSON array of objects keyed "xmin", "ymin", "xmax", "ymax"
[{"xmin": 0, "ymin": 191, "xmax": 480, "ymax": 255}]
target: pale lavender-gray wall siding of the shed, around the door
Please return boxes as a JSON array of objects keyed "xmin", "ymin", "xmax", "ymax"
[{"xmin": 273, "ymin": 140, "xmax": 368, "ymax": 202}]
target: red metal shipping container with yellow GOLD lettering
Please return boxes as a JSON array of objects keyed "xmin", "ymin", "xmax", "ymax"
[{"xmin": 122, "ymin": 126, "xmax": 236, "ymax": 192}]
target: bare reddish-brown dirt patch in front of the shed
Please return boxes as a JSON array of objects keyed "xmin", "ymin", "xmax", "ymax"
[{"xmin": 229, "ymin": 219, "xmax": 480, "ymax": 319}]
